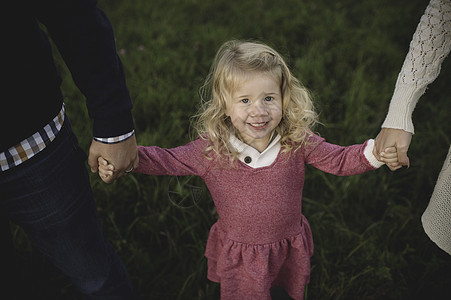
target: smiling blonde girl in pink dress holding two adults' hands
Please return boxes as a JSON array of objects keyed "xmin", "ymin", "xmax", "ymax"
[{"xmin": 99, "ymin": 41, "xmax": 397, "ymax": 300}]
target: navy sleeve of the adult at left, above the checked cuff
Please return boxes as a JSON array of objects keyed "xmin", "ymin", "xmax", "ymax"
[{"xmin": 32, "ymin": 0, "xmax": 134, "ymax": 137}]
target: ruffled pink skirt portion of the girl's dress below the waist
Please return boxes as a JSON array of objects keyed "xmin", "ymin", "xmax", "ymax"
[{"xmin": 205, "ymin": 216, "xmax": 313, "ymax": 294}]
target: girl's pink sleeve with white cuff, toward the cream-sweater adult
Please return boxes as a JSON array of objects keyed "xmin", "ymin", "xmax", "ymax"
[{"xmin": 304, "ymin": 135, "xmax": 384, "ymax": 176}]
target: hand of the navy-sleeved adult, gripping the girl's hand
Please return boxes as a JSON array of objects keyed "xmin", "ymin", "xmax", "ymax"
[{"xmin": 88, "ymin": 135, "xmax": 139, "ymax": 183}]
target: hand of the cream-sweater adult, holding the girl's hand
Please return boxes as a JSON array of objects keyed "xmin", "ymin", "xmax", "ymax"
[{"xmin": 373, "ymin": 128, "xmax": 412, "ymax": 171}]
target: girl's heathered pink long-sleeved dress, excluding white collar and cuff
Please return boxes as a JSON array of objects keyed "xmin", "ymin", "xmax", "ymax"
[{"xmin": 135, "ymin": 135, "xmax": 375, "ymax": 300}]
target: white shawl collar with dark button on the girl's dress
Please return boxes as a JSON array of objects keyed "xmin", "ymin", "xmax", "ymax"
[{"xmin": 229, "ymin": 134, "xmax": 280, "ymax": 169}]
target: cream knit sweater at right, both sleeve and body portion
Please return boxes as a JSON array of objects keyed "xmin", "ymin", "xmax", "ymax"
[{"xmin": 382, "ymin": 0, "xmax": 451, "ymax": 254}]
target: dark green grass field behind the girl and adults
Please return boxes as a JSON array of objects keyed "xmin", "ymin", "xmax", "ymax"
[{"xmin": 8, "ymin": 0, "xmax": 451, "ymax": 300}]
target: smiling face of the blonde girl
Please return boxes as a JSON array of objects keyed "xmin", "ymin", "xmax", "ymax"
[{"xmin": 226, "ymin": 73, "xmax": 282, "ymax": 152}]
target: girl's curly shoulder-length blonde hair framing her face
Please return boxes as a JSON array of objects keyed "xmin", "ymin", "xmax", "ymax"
[{"xmin": 194, "ymin": 40, "xmax": 317, "ymax": 158}]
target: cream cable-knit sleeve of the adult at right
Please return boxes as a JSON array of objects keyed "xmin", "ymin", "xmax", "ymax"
[{"xmin": 382, "ymin": 0, "xmax": 451, "ymax": 133}]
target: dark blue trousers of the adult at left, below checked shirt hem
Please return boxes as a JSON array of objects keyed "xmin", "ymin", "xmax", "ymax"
[{"xmin": 0, "ymin": 116, "xmax": 134, "ymax": 300}]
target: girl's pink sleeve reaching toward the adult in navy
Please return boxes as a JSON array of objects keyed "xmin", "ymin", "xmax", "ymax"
[{"xmin": 134, "ymin": 139, "xmax": 212, "ymax": 177}]
